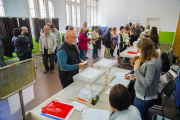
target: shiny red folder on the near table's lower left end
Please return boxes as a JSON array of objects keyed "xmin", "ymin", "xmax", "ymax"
[{"xmin": 42, "ymin": 100, "xmax": 73, "ymax": 119}]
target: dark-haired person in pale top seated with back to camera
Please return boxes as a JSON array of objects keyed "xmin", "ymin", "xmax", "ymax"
[{"xmin": 109, "ymin": 84, "xmax": 141, "ymax": 120}]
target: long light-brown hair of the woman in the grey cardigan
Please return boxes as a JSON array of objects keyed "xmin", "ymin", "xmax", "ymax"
[{"xmin": 137, "ymin": 38, "xmax": 159, "ymax": 63}]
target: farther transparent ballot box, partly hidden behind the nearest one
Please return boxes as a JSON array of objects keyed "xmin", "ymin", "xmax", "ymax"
[{"xmin": 93, "ymin": 58, "xmax": 118, "ymax": 84}]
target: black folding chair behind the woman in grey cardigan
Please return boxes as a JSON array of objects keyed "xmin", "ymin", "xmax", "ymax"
[{"xmin": 151, "ymin": 80, "xmax": 176, "ymax": 116}]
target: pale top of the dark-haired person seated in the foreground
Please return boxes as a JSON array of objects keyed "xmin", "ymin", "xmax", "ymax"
[{"xmin": 109, "ymin": 103, "xmax": 141, "ymax": 120}]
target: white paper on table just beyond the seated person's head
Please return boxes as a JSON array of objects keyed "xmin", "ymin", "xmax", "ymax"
[{"xmin": 109, "ymin": 72, "xmax": 130, "ymax": 87}]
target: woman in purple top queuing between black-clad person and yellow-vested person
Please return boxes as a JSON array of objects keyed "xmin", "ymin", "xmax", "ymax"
[{"xmin": 110, "ymin": 27, "xmax": 118, "ymax": 58}]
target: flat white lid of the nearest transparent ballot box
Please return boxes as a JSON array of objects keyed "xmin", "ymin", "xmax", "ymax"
[{"xmin": 80, "ymin": 69, "xmax": 101, "ymax": 79}]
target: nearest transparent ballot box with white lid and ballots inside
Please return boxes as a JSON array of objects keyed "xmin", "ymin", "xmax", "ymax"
[{"xmin": 73, "ymin": 67, "xmax": 105, "ymax": 101}]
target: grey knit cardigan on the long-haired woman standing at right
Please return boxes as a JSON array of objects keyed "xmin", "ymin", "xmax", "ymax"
[{"xmin": 134, "ymin": 58, "xmax": 162, "ymax": 97}]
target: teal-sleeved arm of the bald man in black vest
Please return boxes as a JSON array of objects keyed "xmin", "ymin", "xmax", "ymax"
[{"xmin": 57, "ymin": 50, "xmax": 79, "ymax": 71}]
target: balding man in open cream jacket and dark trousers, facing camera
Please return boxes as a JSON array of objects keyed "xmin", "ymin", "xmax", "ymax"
[{"xmin": 39, "ymin": 25, "xmax": 57, "ymax": 74}]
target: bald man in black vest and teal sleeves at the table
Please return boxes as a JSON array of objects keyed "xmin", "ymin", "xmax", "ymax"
[{"xmin": 57, "ymin": 30, "xmax": 84, "ymax": 88}]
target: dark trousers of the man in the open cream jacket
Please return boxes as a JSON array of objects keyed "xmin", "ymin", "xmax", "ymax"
[{"xmin": 43, "ymin": 49, "xmax": 54, "ymax": 71}]
